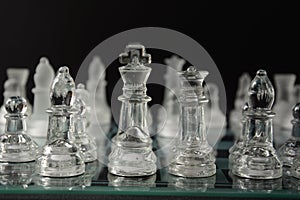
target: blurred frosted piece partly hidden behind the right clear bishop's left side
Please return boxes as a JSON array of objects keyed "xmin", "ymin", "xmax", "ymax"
[{"xmin": 229, "ymin": 73, "xmax": 251, "ymax": 138}]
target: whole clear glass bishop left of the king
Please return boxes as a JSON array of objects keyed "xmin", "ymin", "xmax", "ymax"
[{"xmin": 36, "ymin": 67, "xmax": 85, "ymax": 177}]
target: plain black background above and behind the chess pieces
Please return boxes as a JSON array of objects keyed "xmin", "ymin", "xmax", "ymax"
[{"xmin": 0, "ymin": 0, "xmax": 300, "ymax": 113}]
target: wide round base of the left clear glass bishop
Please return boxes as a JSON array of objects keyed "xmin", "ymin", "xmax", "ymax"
[{"xmin": 36, "ymin": 140, "xmax": 85, "ymax": 177}]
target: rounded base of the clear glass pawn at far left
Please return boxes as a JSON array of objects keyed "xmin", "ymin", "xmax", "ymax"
[{"xmin": 0, "ymin": 133, "xmax": 38, "ymax": 163}]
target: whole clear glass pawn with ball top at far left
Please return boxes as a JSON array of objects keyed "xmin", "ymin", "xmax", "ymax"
[{"xmin": 0, "ymin": 96, "xmax": 38, "ymax": 163}]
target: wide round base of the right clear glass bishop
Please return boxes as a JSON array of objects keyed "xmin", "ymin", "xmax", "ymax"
[{"xmin": 232, "ymin": 146, "xmax": 282, "ymax": 179}]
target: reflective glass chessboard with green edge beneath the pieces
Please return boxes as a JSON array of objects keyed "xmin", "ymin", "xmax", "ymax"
[{"xmin": 0, "ymin": 128, "xmax": 300, "ymax": 199}]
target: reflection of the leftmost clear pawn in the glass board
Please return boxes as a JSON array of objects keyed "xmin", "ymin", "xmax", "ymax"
[{"xmin": 0, "ymin": 162, "xmax": 35, "ymax": 188}]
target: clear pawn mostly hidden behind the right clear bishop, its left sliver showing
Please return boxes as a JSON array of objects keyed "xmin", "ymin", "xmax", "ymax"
[{"xmin": 228, "ymin": 103, "xmax": 249, "ymax": 169}]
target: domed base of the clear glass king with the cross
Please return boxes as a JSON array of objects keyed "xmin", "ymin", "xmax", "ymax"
[{"xmin": 108, "ymin": 127, "xmax": 156, "ymax": 176}]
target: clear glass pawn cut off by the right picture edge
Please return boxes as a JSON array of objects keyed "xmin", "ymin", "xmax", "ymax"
[{"xmin": 278, "ymin": 103, "xmax": 300, "ymax": 170}]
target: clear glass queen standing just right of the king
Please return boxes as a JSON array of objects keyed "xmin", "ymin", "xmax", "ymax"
[{"xmin": 168, "ymin": 66, "xmax": 216, "ymax": 177}]
